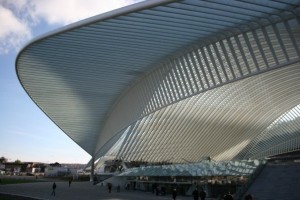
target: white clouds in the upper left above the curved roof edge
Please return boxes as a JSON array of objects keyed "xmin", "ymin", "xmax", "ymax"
[{"xmin": 0, "ymin": 0, "xmax": 141, "ymax": 54}]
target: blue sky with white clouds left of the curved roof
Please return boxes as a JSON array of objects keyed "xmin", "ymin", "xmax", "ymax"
[{"xmin": 0, "ymin": 0, "xmax": 138, "ymax": 163}]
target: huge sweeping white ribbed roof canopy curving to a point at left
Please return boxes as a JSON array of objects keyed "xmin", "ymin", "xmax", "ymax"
[{"xmin": 16, "ymin": 0, "xmax": 300, "ymax": 166}]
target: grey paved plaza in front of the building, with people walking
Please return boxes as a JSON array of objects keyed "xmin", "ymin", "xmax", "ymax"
[{"xmin": 0, "ymin": 181, "xmax": 205, "ymax": 200}]
